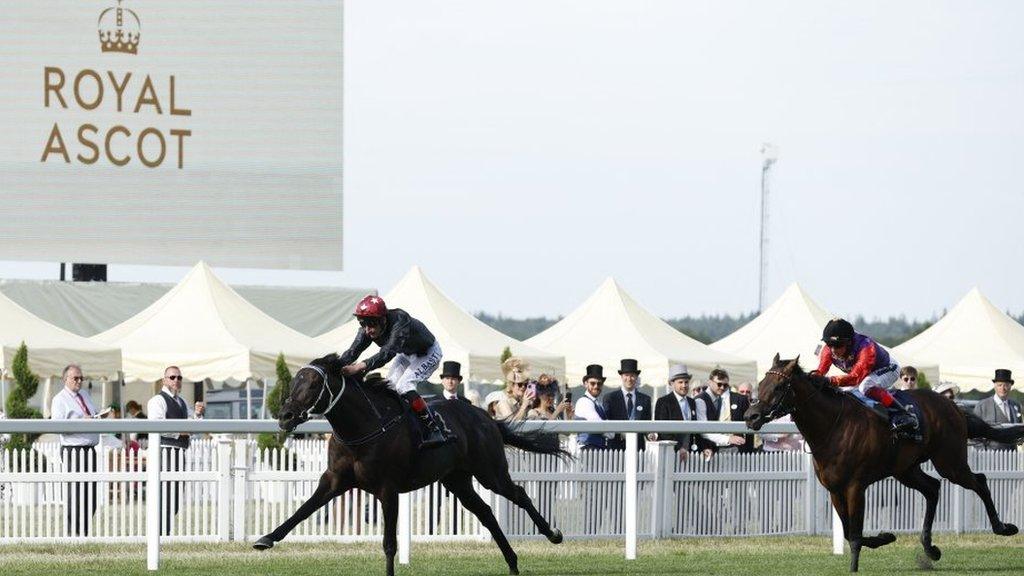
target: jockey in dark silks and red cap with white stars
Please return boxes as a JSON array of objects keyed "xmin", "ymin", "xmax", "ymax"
[{"xmin": 341, "ymin": 294, "xmax": 455, "ymax": 448}]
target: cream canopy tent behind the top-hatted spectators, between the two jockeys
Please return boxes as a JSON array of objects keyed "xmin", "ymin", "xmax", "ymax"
[{"xmin": 526, "ymin": 278, "xmax": 756, "ymax": 387}]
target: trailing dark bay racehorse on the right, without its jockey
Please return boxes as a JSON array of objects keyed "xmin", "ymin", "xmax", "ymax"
[{"xmin": 743, "ymin": 355, "xmax": 1024, "ymax": 572}]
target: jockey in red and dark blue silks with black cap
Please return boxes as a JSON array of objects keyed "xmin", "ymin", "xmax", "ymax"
[{"xmin": 812, "ymin": 318, "xmax": 918, "ymax": 431}]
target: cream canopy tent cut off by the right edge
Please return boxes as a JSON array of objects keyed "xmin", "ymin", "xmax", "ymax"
[{"xmin": 896, "ymin": 288, "xmax": 1024, "ymax": 392}]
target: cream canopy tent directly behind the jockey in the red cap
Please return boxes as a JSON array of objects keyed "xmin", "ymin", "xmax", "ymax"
[{"xmin": 316, "ymin": 266, "xmax": 565, "ymax": 382}]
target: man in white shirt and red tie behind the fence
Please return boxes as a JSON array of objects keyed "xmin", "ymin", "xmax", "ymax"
[{"xmin": 50, "ymin": 364, "xmax": 99, "ymax": 536}]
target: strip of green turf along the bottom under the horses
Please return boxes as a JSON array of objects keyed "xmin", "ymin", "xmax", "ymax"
[{"xmin": 0, "ymin": 535, "xmax": 1024, "ymax": 576}]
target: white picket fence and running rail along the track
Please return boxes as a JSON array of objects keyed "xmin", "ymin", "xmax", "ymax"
[{"xmin": 0, "ymin": 420, "xmax": 1024, "ymax": 568}]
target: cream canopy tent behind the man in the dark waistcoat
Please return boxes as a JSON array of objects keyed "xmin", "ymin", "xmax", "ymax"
[{"xmin": 93, "ymin": 262, "xmax": 330, "ymax": 381}]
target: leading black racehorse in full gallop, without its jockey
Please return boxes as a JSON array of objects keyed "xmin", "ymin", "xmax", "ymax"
[{"xmin": 253, "ymin": 354, "xmax": 568, "ymax": 576}]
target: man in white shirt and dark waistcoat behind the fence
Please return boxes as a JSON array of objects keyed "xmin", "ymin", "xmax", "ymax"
[{"xmin": 145, "ymin": 366, "xmax": 190, "ymax": 535}]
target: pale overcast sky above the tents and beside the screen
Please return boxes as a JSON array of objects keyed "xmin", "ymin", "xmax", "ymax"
[{"xmin": 0, "ymin": 0, "xmax": 1024, "ymax": 318}]
